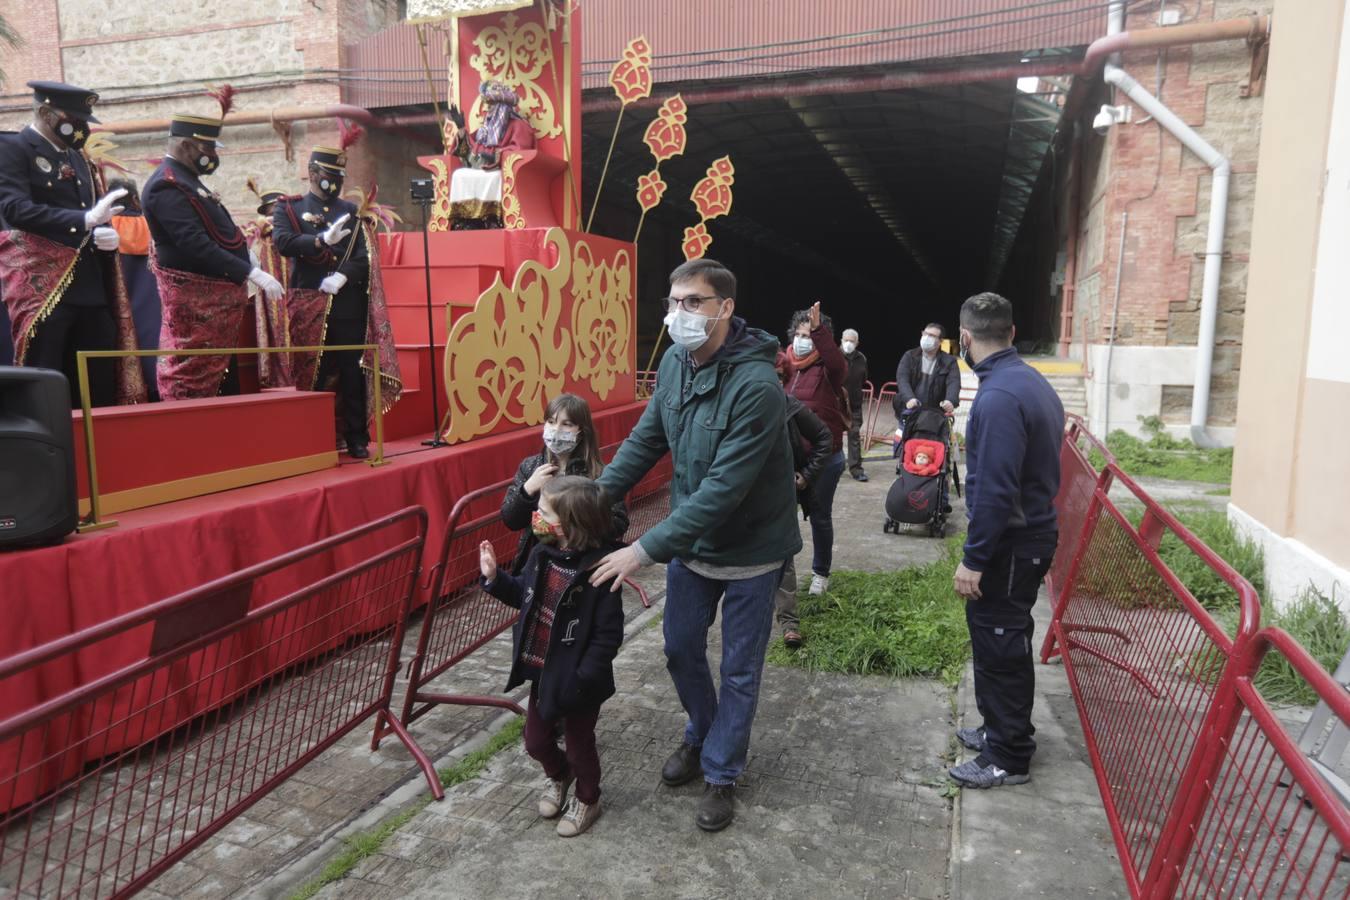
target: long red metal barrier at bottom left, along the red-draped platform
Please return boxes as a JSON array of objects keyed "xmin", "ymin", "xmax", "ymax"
[{"xmin": 0, "ymin": 507, "xmax": 443, "ymax": 897}]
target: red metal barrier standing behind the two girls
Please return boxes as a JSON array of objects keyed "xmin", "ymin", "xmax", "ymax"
[{"xmin": 394, "ymin": 444, "xmax": 671, "ymax": 746}]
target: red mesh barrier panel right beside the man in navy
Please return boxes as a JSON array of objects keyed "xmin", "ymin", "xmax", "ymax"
[{"xmin": 1050, "ymin": 463, "xmax": 1260, "ymax": 896}]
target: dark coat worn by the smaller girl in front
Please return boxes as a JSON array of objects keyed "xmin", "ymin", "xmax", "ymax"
[{"xmin": 482, "ymin": 544, "xmax": 624, "ymax": 722}]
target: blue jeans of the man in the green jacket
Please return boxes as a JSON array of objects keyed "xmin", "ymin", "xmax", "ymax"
[{"xmin": 663, "ymin": 560, "xmax": 783, "ymax": 784}]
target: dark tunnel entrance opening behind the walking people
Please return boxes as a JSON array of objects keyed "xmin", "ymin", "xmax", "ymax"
[{"xmin": 582, "ymin": 78, "xmax": 1067, "ymax": 385}]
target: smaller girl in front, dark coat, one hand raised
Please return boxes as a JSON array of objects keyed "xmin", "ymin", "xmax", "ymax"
[{"xmin": 479, "ymin": 475, "xmax": 624, "ymax": 838}]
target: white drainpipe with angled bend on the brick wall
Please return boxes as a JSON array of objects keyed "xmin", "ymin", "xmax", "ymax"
[{"xmin": 1102, "ymin": 3, "xmax": 1233, "ymax": 447}]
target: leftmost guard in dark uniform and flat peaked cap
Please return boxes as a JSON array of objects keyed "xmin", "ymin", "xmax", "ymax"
[{"xmin": 0, "ymin": 81, "xmax": 131, "ymax": 406}]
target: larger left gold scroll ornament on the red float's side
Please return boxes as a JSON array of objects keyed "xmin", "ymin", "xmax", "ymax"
[{"xmin": 444, "ymin": 228, "xmax": 572, "ymax": 444}]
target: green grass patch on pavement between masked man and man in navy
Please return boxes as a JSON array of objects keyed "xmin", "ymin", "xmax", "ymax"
[{"xmin": 768, "ymin": 537, "xmax": 971, "ymax": 685}]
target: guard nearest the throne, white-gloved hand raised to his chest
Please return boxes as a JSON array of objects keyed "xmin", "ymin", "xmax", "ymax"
[{"xmin": 271, "ymin": 147, "xmax": 370, "ymax": 459}]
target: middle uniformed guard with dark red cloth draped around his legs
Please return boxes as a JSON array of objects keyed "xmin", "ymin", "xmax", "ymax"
[{"xmin": 140, "ymin": 115, "xmax": 285, "ymax": 399}]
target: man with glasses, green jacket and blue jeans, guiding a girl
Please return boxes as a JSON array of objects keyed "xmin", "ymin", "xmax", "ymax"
[{"xmin": 591, "ymin": 259, "xmax": 802, "ymax": 831}]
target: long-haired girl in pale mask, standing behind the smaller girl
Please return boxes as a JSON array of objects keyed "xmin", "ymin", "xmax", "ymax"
[{"xmin": 502, "ymin": 394, "xmax": 628, "ymax": 575}]
